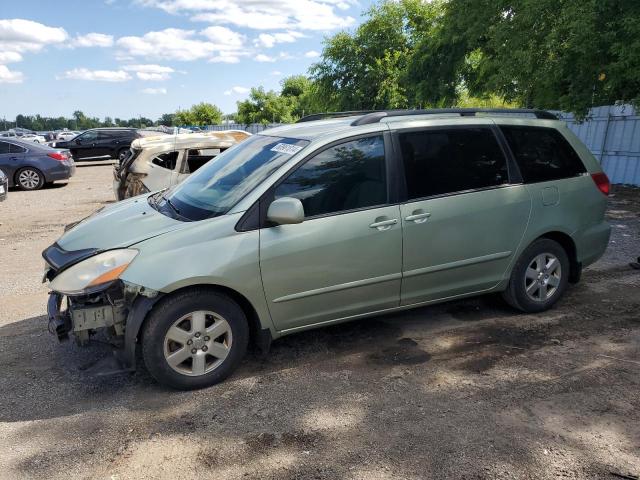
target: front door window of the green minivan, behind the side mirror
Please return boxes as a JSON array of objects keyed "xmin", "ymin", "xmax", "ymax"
[{"xmin": 275, "ymin": 136, "xmax": 387, "ymax": 217}]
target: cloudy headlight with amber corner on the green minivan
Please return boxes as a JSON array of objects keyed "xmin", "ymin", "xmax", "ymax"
[{"xmin": 51, "ymin": 248, "xmax": 138, "ymax": 296}]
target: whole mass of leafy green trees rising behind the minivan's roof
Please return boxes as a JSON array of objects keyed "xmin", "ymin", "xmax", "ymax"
[{"xmin": 310, "ymin": 0, "xmax": 640, "ymax": 115}]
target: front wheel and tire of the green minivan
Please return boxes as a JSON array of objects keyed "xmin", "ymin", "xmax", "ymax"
[{"xmin": 142, "ymin": 288, "xmax": 249, "ymax": 390}]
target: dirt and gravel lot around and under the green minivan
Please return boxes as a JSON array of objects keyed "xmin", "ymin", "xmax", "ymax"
[{"xmin": 0, "ymin": 165, "xmax": 640, "ymax": 480}]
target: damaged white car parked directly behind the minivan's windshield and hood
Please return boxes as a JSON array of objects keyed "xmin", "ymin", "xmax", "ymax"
[{"xmin": 113, "ymin": 130, "xmax": 251, "ymax": 200}]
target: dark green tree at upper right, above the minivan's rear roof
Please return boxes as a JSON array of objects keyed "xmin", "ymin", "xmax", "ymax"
[{"xmin": 408, "ymin": 0, "xmax": 640, "ymax": 115}]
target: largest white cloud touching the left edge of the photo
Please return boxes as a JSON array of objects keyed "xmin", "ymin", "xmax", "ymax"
[{"xmin": 0, "ymin": 18, "xmax": 68, "ymax": 53}]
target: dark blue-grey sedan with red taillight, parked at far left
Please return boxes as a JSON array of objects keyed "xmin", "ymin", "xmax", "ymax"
[{"xmin": 0, "ymin": 138, "xmax": 76, "ymax": 190}]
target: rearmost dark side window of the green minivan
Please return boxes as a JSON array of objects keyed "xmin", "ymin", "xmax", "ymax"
[{"xmin": 500, "ymin": 125, "xmax": 586, "ymax": 183}]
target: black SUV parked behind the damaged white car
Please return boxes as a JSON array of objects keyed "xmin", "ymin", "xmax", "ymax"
[{"xmin": 52, "ymin": 127, "xmax": 163, "ymax": 161}]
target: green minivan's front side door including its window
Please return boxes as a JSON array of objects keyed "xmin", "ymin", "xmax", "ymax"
[{"xmin": 260, "ymin": 134, "xmax": 402, "ymax": 330}]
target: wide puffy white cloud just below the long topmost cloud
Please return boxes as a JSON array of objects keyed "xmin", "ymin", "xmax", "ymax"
[{"xmin": 116, "ymin": 26, "xmax": 248, "ymax": 63}]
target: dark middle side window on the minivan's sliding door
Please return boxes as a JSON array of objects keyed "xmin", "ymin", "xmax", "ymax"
[{"xmin": 399, "ymin": 128, "xmax": 509, "ymax": 200}]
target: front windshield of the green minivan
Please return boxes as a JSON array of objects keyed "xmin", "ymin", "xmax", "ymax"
[{"xmin": 165, "ymin": 135, "xmax": 309, "ymax": 220}]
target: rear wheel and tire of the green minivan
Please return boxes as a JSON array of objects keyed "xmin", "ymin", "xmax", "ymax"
[{"xmin": 502, "ymin": 238, "xmax": 570, "ymax": 313}]
